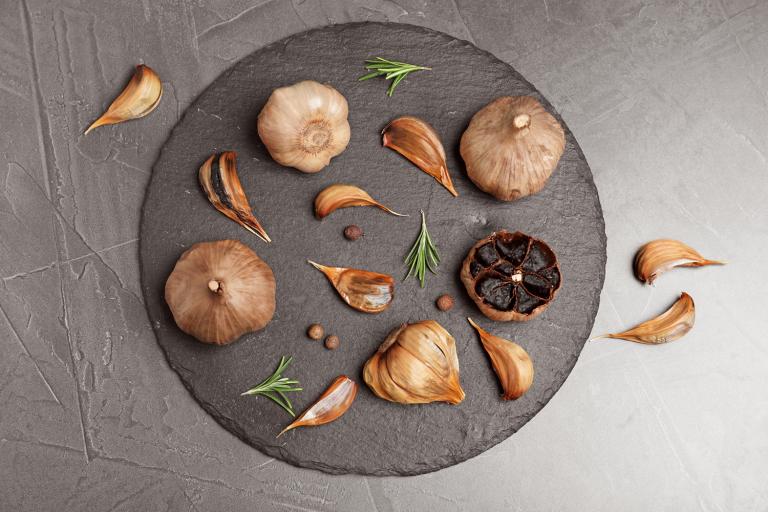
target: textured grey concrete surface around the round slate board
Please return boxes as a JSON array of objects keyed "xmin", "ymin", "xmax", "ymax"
[{"xmin": 0, "ymin": 0, "xmax": 768, "ymax": 512}]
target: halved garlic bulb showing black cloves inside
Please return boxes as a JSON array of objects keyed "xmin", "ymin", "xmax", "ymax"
[{"xmin": 461, "ymin": 230, "xmax": 561, "ymax": 322}]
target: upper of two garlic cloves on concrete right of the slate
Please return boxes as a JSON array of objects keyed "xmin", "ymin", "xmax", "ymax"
[{"xmin": 635, "ymin": 239, "xmax": 725, "ymax": 284}]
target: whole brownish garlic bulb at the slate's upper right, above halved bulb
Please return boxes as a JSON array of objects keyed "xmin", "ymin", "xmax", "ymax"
[{"xmin": 459, "ymin": 96, "xmax": 565, "ymax": 201}]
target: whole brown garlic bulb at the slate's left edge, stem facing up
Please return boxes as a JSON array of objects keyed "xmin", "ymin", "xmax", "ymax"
[{"xmin": 165, "ymin": 240, "xmax": 275, "ymax": 345}]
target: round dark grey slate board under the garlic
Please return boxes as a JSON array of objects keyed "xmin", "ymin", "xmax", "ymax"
[{"xmin": 141, "ymin": 23, "xmax": 606, "ymax": 475}]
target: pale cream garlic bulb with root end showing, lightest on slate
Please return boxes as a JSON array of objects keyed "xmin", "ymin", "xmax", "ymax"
[{"xmin": 258, "ymin": 80, "xmax": 350, "ymax": 173}]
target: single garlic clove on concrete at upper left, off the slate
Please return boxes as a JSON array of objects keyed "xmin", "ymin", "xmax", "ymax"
[{"xmin": 84, "ymin": 64, "xmax": 163, "ymax": 135}]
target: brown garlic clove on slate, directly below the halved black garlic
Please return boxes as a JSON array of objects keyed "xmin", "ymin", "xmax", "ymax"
[{"xmin": 467, "ymin": 318, "xmax": 533, "ymax": 400}]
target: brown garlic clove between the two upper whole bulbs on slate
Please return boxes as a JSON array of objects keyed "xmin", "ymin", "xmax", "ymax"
[{"xmin": 381, "ymin": 116, "xmax": 459, "ymax": 197}]
